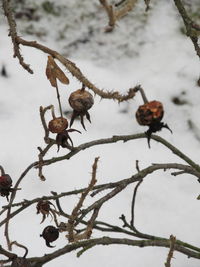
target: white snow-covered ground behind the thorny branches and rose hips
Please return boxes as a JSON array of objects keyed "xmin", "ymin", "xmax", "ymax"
[{"xmin": 0, "ymin": 0, "xmax": 200, "ymax": 267}]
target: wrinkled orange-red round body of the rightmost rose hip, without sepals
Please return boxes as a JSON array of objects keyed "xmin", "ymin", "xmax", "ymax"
[{"xmin": 136, "ymin": 100, "xmax": 164, "ymax": 126}]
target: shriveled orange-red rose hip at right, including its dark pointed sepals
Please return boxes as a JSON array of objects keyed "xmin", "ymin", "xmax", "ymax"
[{"xmin": 135, "ymin": 100, "xmax": 172, "ymax": 147}]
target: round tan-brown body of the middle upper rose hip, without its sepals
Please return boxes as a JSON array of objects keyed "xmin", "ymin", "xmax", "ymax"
[{"xmin": 69, "ymin": 89, "xmax": 94, "ymax": 114}]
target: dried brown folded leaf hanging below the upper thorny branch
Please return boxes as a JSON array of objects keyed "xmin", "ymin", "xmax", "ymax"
[{"xmin": 46, "ymin": 56, "xmax": 69, "ymax": 87}]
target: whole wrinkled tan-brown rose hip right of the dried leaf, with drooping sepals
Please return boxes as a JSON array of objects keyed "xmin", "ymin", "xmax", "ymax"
[{"xmin": 69, "ymin": 89, "xmax": 94, "ymax": 129}]
